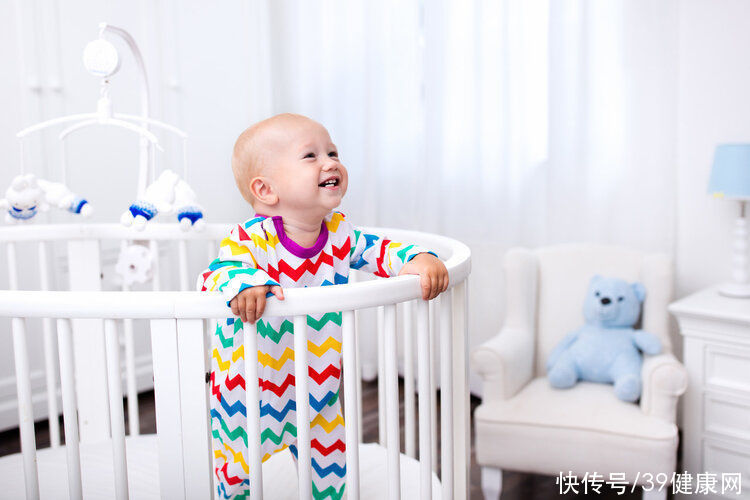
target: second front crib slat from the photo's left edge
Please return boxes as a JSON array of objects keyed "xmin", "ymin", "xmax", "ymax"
[{"xmin": 57, "ymin": 319, "xmax": 83, "ymax": 500}]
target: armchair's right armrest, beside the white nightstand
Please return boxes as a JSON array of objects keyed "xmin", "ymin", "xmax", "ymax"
[{"xmin": 641, "ymin": 353, "xmax": 688, "ymax": 422}]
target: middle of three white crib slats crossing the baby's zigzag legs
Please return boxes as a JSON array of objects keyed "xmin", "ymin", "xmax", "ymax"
[{"xmin": 294, "ymin": 315, "xmax": 312, "ymax": 500}]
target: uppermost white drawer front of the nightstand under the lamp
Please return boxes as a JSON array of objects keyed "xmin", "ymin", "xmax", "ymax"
[{"xmin": 704, "ymin": 344, "xmax": 750, "ymax": 396}]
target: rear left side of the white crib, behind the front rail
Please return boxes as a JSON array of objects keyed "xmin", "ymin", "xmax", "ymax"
[{"xmin": 0, "ymin": 222, "xmax": 230, "ymax": 447}]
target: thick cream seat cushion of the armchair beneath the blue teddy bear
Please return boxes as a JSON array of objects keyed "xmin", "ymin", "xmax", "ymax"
[{"xmin": 474, "ymin": 377, "xmax": 678, "ymax": 483}]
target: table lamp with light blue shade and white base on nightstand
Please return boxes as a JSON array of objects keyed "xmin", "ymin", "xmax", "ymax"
[{"xmin": 708, "ymin": 144, "xmax": 750, "ymax": 298}]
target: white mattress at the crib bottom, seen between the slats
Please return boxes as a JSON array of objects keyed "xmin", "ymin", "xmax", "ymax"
[{"xmin": 0, "ymin": 434, "xmax": 440, "ymax": 500}]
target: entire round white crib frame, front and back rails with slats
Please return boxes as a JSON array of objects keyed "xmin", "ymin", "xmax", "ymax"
[{"xmin": 0, "ymin": 223, "xmax": 471, "ymax": 500}]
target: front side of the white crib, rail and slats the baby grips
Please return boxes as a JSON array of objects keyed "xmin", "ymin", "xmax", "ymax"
[{"xmin": 0, "ymin": 226, "xmax": 470, "ymax": 499}]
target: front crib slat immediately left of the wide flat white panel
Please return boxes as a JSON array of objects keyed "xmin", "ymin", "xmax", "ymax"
[{"xmin": 104, "ymin": 319, "xmax": 128, "ymax": 500}]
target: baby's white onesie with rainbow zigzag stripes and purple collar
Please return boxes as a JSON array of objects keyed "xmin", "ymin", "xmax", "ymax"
[{"xmin": 198, "ymin": 212, "xmax": 434, "ymax": 500}]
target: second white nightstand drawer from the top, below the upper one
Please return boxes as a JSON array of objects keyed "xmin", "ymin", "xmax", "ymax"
[{"xmin": 703, "ymin": 392, "xmax": 750, "ymax": 440}]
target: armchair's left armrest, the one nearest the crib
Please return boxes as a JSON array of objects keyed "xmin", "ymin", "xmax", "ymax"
[{"xmin": 471, "ymin": 326, "xmax": 534, "ymax": 402}]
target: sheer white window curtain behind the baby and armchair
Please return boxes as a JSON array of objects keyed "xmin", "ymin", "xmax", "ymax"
[{"xmin": 251, "ymin": 0, "xmax": 678, "ymax": 392}]
